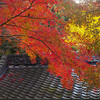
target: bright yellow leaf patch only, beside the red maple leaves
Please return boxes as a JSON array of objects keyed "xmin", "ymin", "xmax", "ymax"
[{"xmin": 65, "ymin": 16, "xmax": 100, "ymax": 53}]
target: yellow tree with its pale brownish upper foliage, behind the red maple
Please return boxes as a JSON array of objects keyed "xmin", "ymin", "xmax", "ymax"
[{"xmin": 54, "ymin": 0, "xmax": 100, "ymax": 54}]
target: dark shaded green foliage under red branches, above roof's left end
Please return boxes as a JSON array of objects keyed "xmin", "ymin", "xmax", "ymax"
[{"xmin": 0, "ymin": 27, "xmax": 25, "ymax": 55}]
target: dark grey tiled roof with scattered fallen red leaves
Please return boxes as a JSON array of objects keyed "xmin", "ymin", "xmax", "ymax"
[{"xmin": 0, "ymin": 55, "xmax": 100, "ymax": 100}]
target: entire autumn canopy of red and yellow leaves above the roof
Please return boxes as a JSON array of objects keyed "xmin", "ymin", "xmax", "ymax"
[{"xmin": 0, "ymin": 0, "xmax": 100, "ymax": 89}]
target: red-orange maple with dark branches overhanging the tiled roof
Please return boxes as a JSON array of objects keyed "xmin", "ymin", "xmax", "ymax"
[{"xmin": 0, "ymin": 0, "xmax": 100, "ymax": 89}]
